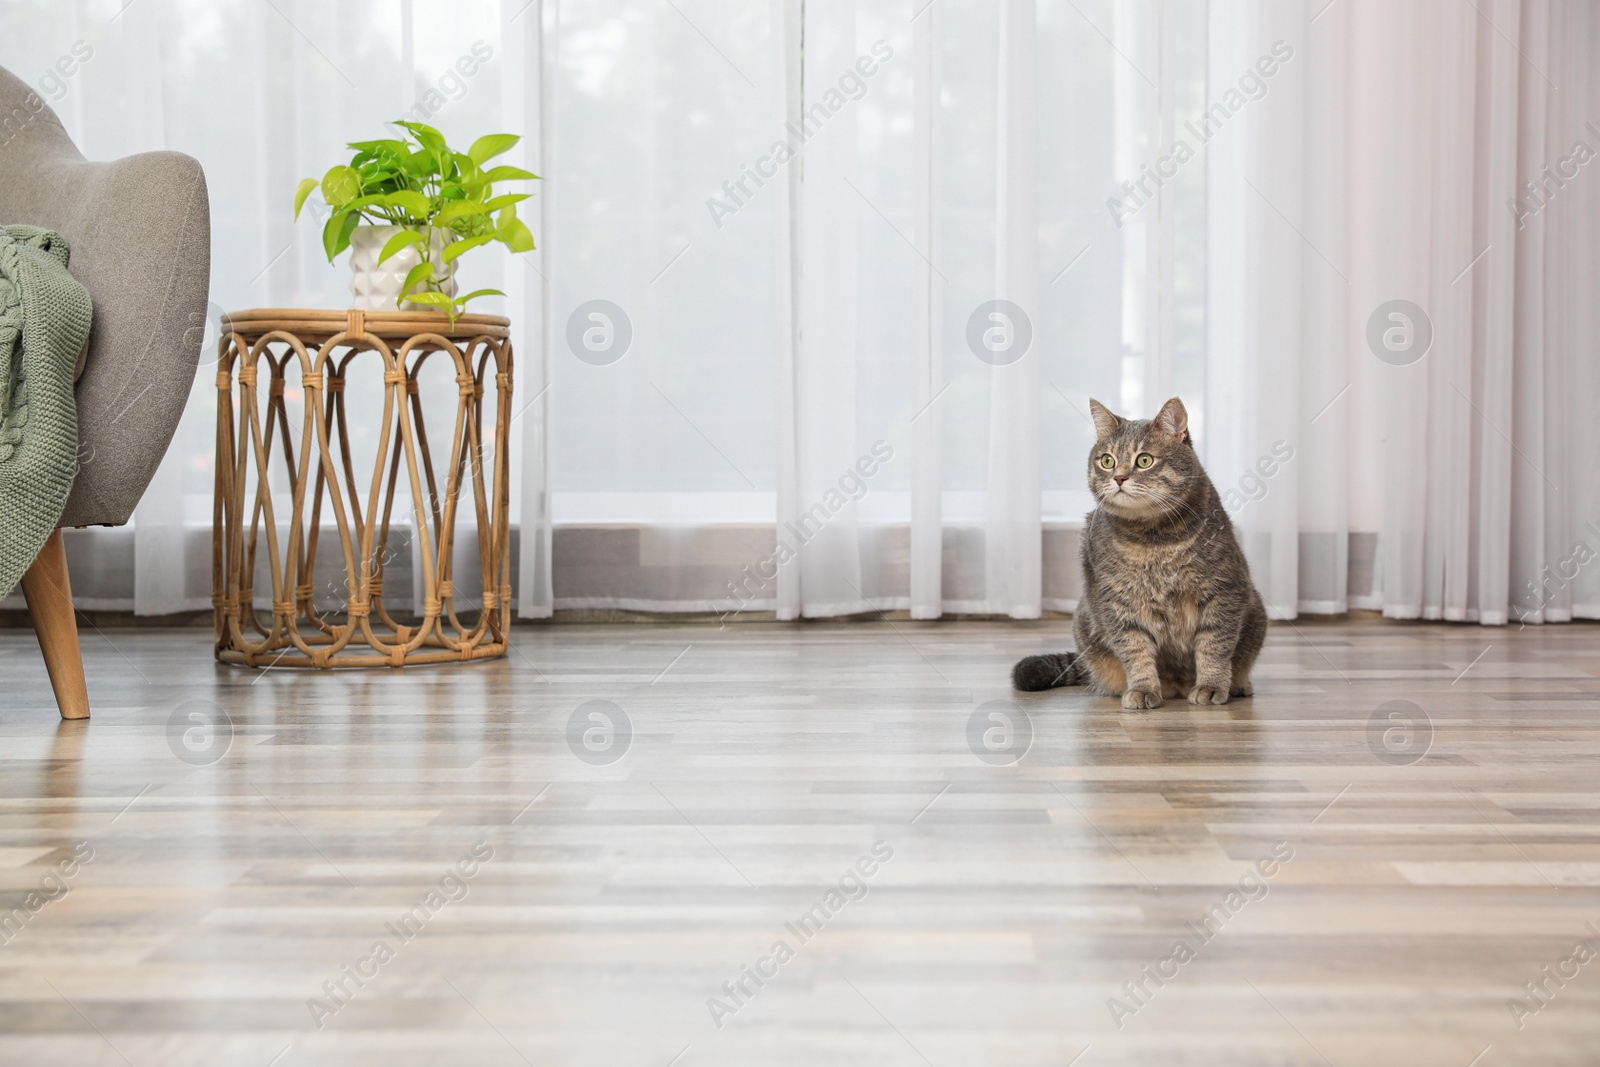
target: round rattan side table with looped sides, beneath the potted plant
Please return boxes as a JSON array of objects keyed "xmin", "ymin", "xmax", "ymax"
[{"xmin": 211, "ymin": 309, "xmax": 512, "ymax": 667}]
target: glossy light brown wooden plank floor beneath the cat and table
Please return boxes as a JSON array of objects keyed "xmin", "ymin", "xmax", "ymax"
[{"xmin": 0, "ymin": 621, "xmax": 1600, "ymax": 1067}]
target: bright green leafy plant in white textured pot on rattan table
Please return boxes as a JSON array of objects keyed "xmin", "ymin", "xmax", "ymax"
[{"xmin": 294, "ymin": 122, "xmax": 538, "ymax": 325}]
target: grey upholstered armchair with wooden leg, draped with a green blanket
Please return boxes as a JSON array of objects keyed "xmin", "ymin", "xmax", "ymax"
[{"xmin": 0, "ymin": 69, "xmax": 211, "ymax": 718}]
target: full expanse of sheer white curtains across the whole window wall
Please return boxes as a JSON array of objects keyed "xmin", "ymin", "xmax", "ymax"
[{"xmin": 0, "ymin": 0, "xmax": 1600, "ymax": 622}]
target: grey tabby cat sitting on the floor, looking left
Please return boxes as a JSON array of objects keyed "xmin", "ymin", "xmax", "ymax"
[{"xmin": 1011, "ymin": 397, "xmax": 1267, "ymax": 709}]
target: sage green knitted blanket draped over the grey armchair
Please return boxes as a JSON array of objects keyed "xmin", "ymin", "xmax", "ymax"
[{"xmin": 0, "ymin": 226, "xmax": 93, "ymax": 597}]
